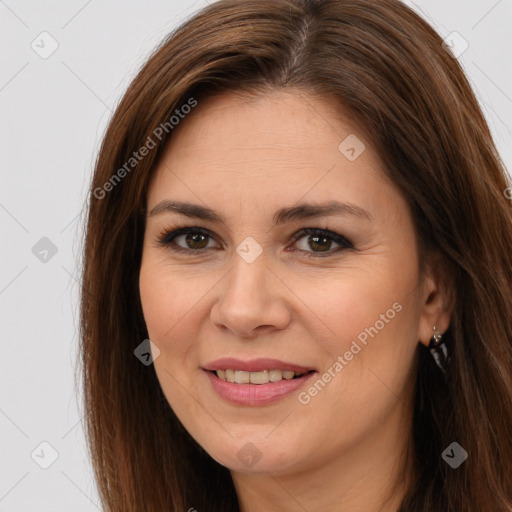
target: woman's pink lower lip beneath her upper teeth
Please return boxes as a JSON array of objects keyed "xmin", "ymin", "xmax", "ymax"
[{"xmin": 205, "ymin": 370, "xmax": 317, "ymax": 405}]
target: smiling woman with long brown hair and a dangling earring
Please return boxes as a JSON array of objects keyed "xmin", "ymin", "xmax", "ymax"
[{"xmin": 81, "ymin": 0, "xmax": 512, "ymax": 512}]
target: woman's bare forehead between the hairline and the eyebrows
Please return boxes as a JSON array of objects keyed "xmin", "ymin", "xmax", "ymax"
[{"xmin": 148, "ymin": 91, "xmax": 392, "ymax": 220}]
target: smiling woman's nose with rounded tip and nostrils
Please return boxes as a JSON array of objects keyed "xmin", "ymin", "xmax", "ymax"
[{"xmin": 210, "ymin": 250, "xmax": 291, "ymax": 338}]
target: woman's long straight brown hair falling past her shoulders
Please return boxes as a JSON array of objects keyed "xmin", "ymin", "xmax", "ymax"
[{"xmin": 80, "ymin": 0, "xmax": 512, "ymax": 512}]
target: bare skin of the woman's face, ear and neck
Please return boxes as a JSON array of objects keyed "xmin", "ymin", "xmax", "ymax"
[{"xmin": 140, "ymin": 90, "xmax": 453, "ymax": 512}]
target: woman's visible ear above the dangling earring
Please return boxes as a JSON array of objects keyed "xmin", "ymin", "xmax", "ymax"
[{"xmin": 418, "ymin": 252, "xmax": 455, "ymax": 347}]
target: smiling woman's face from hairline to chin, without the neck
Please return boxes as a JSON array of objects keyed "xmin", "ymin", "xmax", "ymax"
[{"xmin": 140, "ymin": 88, "xmax": 431, "ymax": 474}]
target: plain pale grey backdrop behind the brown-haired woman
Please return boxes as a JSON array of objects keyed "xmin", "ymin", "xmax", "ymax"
[{"xmin": 0, "ymin": 0, "xmax": 512, "ymax": 512}]
